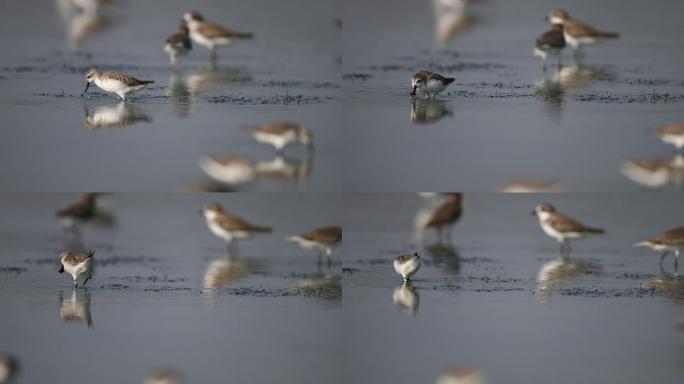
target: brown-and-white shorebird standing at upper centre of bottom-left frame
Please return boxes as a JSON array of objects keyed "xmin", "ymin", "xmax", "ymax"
[{"xmin": 202, "ymin": 203, "xmax": 271, "ymax": 253}]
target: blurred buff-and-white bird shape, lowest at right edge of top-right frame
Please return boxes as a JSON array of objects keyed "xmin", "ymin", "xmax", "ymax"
[{"xmin": 620, "ymin": 154, "xmax": 684, "ymax": 189}]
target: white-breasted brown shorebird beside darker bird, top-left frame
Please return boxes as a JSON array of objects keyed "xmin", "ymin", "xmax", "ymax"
[{"xmin": 183, "ymin": 11, "xmax": 252, "ymax": 62}]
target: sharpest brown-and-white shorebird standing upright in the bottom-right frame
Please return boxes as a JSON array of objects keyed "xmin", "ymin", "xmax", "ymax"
[{"xmin": 532, "ymin": 204, "xmax": 604, "ymax": 253}]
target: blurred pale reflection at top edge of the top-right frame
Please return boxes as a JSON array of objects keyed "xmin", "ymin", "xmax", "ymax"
[{"xmin": 432, "ymin": 0, "xmax": 479, "ymax": 45}]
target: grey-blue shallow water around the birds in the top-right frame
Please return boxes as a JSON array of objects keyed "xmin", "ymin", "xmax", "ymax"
[{"xmin": 343, "ymin": 0, "xmax": 684, "ymax": 192}]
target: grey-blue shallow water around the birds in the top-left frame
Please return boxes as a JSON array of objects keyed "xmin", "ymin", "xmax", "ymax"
[{"xmin": 0, "ymin": 0, "xmax": 341, "ymax": 192}]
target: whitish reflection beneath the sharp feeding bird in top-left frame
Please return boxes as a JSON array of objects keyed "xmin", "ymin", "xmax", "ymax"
[{"xmin": 83, "ymin": 101, "xmax": 153, "ymax": 132}]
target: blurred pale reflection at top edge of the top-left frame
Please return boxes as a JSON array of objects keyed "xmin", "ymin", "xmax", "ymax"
[{"xmin": 56, "ymin": 0, "xmax": 113, "ymax": 49}]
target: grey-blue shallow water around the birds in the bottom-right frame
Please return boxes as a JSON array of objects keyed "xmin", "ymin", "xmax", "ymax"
[{"xmin": 343, "ymin": 194, "xmax": 684, "ymax": 383}]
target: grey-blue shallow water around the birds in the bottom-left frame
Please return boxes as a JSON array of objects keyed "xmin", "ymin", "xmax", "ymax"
[{"xmin": 0, "ymin": 194, "xmax": 343, "ymax": 383}]
